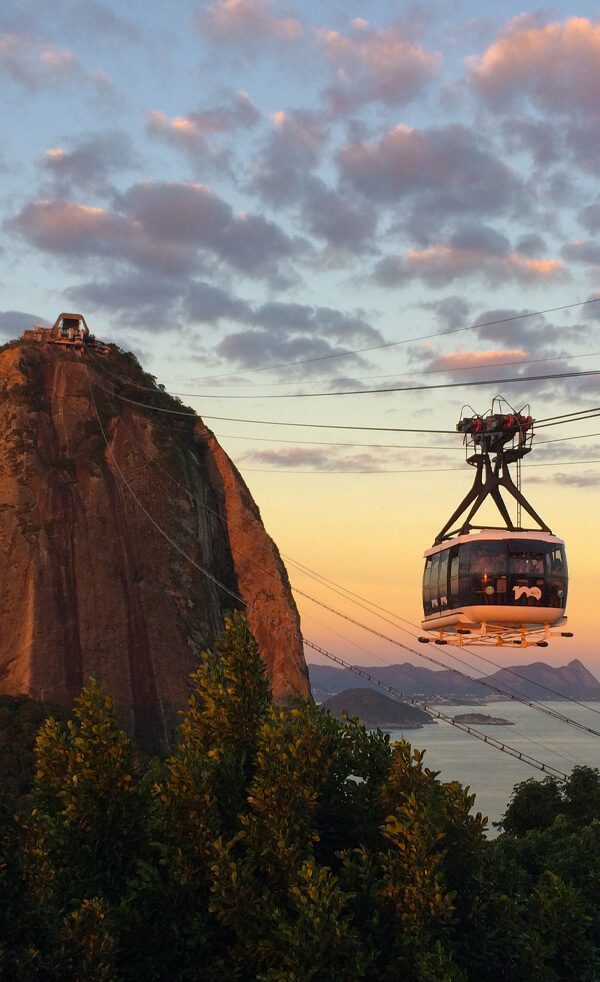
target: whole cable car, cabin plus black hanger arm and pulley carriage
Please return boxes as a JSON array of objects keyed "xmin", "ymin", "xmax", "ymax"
[{"xmin": 419, "ymin": 397, "xmax": 572, "ymax": 648}]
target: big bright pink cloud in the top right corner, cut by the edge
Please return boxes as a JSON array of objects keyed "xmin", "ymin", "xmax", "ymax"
[{"xmin": 467, "ymin": 17, "xmax": 600, "ymax": 114}]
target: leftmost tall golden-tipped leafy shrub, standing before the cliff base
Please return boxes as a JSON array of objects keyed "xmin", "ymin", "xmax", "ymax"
[{"xmin": 33, "ymin": 680, "xmax": 146, "ymax": 909}]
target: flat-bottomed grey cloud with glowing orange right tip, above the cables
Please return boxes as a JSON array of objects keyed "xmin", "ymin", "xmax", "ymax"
[{"xmin": 374, "ymin": 225, "xmax": 566, "ymax": 287}]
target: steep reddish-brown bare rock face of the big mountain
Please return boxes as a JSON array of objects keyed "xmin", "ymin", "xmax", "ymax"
[{"xmin": 0, "ymin": 342, "xmax": 310, "ymax": 747}]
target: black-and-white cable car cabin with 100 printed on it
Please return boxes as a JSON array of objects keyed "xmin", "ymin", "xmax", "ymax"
[{"xmin": 421, "ymin": 529, "xmax": 568, "ymax": 643}]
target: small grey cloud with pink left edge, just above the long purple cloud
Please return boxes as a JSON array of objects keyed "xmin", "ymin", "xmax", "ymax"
[{"xmin": 42, "ymin": 130, "xmax": 139, "ymax": 197}]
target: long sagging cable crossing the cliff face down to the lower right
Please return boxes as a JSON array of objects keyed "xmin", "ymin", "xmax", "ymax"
[{"xmin": 86, "ymin": 369, "xmax": 567, "ymax": 781}]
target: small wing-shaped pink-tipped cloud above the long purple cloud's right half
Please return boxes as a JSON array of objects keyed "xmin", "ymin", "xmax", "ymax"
[{"xmin": 146, "ymin": 92, "xmax": 261, "ymax": 164}]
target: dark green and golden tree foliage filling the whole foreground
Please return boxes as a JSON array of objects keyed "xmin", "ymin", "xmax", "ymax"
[{"xmin": 0, "ymin": 613, "xmax": 600, "ymax": 982}]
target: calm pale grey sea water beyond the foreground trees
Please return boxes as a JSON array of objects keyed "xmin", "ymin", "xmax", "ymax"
[{"xmin": 389, "ymin": 701, "xmax": 600, "ymax": 835}]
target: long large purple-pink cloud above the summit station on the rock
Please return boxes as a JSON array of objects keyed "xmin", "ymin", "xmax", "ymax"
[{"xmin": 5, "ymin": 182, "xmax": 306, "ymax": 285}]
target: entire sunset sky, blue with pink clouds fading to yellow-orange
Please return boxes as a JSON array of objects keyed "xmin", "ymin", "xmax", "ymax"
[{"xmin": 0, "ymin": 0, "xmax": 600, "ymax": 673}]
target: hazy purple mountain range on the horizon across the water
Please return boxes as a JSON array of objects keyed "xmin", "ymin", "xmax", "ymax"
[{"xmin": 308, "ymin": 658, "xmax": 600, "ymax": 703}]
